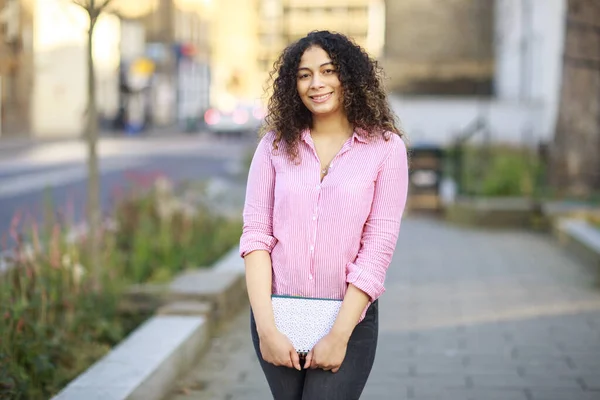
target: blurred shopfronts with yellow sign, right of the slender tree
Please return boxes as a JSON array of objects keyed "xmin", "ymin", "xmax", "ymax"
[{"xmin": 117, "ymin": 0, "xmax": 211, "ymax": 132}]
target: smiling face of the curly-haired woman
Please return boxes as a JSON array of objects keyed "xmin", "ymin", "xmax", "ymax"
[{"xmin": 296, "ymin": 46, "xmax": 343, "ymax": 116}]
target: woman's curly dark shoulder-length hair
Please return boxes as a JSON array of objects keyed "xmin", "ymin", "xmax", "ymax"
[{"xmin": 261, "ymin": 31, "xmax": 403, "ymax": 160}]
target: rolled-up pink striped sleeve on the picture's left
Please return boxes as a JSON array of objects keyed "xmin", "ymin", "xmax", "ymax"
[{"xmin": 240, "ymin": 134, "xmax": 277, "ymax": 257}]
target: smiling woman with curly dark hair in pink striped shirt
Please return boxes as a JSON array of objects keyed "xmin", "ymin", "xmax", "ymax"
[{"xmin": 240, "ymin": 31, "xmax": 408, "ymax": 400}]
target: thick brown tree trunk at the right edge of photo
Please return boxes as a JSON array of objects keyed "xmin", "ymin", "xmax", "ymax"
[{"xmin": 549, "ymin": 0, "xmax": 600, "ymax": 197}]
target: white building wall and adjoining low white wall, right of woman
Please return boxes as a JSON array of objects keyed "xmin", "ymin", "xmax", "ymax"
[{"xmin": 391, "ymin": 0, "xmax": 566, "ymax": 145}]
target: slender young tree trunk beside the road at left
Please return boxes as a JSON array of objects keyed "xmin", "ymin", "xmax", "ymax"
[{"xmin": 72, "ymin": 0, "xmax": 112, "ymax": 289}]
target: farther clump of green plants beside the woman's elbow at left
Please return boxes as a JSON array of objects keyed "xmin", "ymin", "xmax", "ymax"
[{"xmin": 115, "ymin": 180, "xmax": 241, "ymax": 283}]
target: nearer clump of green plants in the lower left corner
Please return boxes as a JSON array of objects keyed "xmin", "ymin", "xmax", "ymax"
[{"xmin": 0, "ymin": 223, "xmax": 125, "ymax": 399}]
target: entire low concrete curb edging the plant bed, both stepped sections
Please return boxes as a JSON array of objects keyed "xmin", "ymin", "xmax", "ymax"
[{"xmin": 53, "ymin": 248, "xmax": 247, "ymax": 400}]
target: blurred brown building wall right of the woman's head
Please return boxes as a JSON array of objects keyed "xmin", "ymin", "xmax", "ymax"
[{"xmin": 382, "ymin": 0, "xmax": 494, "ymax": 94}]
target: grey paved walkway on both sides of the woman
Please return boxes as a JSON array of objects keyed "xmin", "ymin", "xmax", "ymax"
[{"xmin": 171, "ymin": 218, "xmax": 600, "ymax": 400}]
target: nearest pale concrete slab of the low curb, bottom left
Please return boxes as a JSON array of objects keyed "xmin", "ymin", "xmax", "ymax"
[{"xmin": 53, "ymin": 316, "xmax": 209, "ymax": 400}]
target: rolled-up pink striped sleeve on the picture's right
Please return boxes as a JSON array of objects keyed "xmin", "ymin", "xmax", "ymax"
[{"xmin": 346, "ymin": 136, "xmax": 408, "ymax": 301}]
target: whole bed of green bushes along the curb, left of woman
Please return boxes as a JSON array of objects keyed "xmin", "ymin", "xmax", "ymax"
[{"xmin": 0, "ymin": 180, "xmax": 241, "ymax": 400}]
